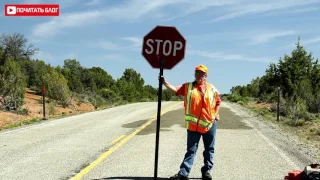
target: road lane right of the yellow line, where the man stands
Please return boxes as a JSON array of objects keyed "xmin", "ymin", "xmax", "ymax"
[{"xmin": 78, "ymin": 103, "xmax": 316, "ymax": 180}]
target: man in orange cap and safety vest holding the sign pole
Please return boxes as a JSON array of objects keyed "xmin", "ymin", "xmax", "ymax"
[{"xmin": 162, "ymin": 65, "xmax": 221, "ymax": 180}]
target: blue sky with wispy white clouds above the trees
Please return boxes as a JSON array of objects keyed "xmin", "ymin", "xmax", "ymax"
[{"xmin": 0, "ymin": 0, "xmax": 320, "ymax": 93}]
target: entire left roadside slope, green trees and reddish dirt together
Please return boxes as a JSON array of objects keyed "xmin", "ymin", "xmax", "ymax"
[{"xmin": 0, "ymin": 33, "xmax": 180, "ymax": 131}]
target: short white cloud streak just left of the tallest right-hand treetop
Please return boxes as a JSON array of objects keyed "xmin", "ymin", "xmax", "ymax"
[{"xmin": 249, "ymin": 30, "xmax": 295, "ymax": 45}]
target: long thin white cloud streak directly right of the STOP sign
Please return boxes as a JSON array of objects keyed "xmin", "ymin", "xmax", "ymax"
[{"xmin": 188, "ymin": 50, "xmax": 272, "ymax": 63}]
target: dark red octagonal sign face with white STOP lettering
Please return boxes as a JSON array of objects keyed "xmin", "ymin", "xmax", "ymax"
[{"xmin": 142, "ymin": 26, "xmax": 186, "ymax": 69}]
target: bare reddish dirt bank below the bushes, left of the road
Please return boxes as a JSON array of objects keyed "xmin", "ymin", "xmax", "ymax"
[{"xmin": 0, "ymin": 88, "xmax": 94, "ymax": 129}]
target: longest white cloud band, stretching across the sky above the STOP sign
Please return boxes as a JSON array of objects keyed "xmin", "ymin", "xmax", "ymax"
[{"xmin": 32, "ymin": 0, "xmax": 241, "ymax": 37}]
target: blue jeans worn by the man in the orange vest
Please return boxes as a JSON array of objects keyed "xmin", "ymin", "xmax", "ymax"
[{"xmin": 179, "ymin": 121, "xmax": 218, "ymax": 176}]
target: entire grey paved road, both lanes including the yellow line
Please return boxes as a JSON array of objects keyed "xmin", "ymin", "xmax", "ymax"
[{"xmin": 0, "ymin": 102, "xmax": 316, "ymax": 180}]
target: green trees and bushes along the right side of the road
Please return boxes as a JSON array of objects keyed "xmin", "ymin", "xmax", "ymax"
[{"xmin": 226, "ymin": 37, "xmax": 320, "ymax": 125}]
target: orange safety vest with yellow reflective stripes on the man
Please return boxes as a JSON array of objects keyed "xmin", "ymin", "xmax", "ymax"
[{"xmin": 184, "ymin": 82, "xmax": 218, "ymax": 133}]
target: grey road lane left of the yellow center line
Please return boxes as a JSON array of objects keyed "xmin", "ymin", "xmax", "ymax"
[{"xmin": 0, "ymin": 102, "xmax": 176, "ymax": 180}]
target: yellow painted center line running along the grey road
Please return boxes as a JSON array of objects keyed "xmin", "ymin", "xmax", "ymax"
[{"xmin": 72, "ymin": 102, "xmax": 181, "ymax": 180}]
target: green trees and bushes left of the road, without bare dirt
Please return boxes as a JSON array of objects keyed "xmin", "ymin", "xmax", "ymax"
[{"xmin": 0, "ymin": 33, "xmax": 180, "ymax": 111}]
